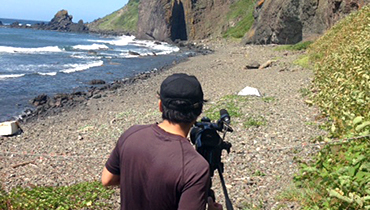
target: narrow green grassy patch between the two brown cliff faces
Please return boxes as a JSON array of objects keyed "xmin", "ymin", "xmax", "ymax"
[{"xmin": 223, "ymin": 0, "xmax": 255, "ymax": 38}]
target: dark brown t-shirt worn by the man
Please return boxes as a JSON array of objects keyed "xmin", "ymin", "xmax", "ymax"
[{"xmin": 105, "ymin": 124, "xmax": 209, "ymax": 210}]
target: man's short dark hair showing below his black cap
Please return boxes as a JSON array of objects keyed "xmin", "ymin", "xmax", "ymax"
[{"xmin": 162, "ymin": 100, "xmax": 203, "ymax": 123}]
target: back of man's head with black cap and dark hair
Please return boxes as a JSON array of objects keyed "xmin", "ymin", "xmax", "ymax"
[{"xmin": 159, "ymin": 74, "xmax": 204, "ymax": 123}]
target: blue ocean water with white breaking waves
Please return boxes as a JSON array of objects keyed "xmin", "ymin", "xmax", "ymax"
[{"xmin": 0, "ymin": 18, "xmax": 192, "ymax": 122}]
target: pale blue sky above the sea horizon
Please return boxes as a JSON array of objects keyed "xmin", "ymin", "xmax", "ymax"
[{"xmin": 0, "ymin": 0, "xmax": 128, "ymax": 22}]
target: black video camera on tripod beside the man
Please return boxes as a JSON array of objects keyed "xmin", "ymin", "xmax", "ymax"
[{"xmin": 190, "ymin": 109, "xmax": 233, "ymax": 210}]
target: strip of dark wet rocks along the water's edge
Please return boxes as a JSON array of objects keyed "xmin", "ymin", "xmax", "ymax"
[{"xmin": 4, "ymin": 36, "xmax": 213, "ymax": 123}]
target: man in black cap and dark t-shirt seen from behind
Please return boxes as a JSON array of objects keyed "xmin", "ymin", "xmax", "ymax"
[{"xmin": 102, "ymin": 74, "xmax": 222, "ymax": 210}]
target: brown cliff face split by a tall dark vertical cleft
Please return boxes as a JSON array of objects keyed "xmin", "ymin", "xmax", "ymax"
[{"xmin": 137, "ymin": 0, "xmax": 230, "ymax": 41}]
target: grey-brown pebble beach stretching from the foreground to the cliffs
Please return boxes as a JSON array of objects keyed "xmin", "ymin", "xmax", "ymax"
[{"xmin": 0, "ymin": 41, "xmax": 322, "ymax": 209}]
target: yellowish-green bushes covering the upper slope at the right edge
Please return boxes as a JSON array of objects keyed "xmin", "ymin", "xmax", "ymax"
[{"xmin": 309, "ymin": 6, "xmax": 370, "ymax": 137}]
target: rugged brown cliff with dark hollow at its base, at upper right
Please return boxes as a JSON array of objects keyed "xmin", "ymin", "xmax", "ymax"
[{"xmin": 243, "ymin": 0, "xmax": 369, "ymax": 44}]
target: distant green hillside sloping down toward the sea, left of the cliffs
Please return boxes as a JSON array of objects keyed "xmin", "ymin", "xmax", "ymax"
[{"xmin": 90, "ymin": 0, "xmax": 139, "ymax": 32}]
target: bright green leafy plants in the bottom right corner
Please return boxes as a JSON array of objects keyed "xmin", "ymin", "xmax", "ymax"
[{"xmin": 295, "ymin": 138, "xmax": 370, "ymax": 209}]
